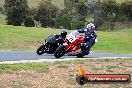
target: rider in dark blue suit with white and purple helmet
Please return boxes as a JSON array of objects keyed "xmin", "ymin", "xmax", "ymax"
[{"xmin": 78, "ymin": 23, "xmax": 97, "ymax": 55}]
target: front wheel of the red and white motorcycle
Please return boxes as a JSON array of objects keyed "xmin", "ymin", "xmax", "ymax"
[{"xmin": 54, "ymin": 45, "xmax": 65, "ymax": 58}]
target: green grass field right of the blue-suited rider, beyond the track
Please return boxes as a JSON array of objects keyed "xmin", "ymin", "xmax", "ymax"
[{"xmin": 93, "ymin": 29, "xmax": 132, "ymax": 53}]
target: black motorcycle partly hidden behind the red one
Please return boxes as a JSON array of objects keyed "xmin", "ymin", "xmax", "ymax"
[{"xmin": 37, "ymin": 34, "xmax": 63, "ymax": 55}]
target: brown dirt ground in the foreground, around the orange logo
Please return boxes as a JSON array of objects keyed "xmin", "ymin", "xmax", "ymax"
[{"xmin": 0, "ymin": 60, "xmax": 132, "ymax": 88}]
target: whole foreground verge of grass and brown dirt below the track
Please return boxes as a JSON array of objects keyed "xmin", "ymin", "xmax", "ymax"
[{"xmin": 0, "ymin": 58, "xmax": 132, "ymax": 88}]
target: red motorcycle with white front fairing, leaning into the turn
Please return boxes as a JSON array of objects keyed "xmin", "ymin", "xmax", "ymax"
[{"xmin": 54, "ymin": 30, "xmax": 85, "ymax": 58}]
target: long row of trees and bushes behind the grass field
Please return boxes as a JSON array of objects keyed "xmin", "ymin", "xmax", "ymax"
[{"xmin": 4, "ymin": 0, "xmax": 132, "ymax": 31}]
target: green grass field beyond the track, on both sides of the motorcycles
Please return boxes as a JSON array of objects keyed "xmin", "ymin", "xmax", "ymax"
[{"xmin": 0, "ymin": 25, "xmax": 132, "ymax": 53}]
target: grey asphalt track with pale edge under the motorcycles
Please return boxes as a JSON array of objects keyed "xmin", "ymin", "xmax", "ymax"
[{"xmin": 0, "ymin": 51, "xmax": 132, "ymax": 62}]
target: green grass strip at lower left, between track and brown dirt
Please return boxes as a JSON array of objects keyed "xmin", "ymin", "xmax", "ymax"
[{"xmin": 0, "ymin": 62, "xmax": 51, "ymax": 73}]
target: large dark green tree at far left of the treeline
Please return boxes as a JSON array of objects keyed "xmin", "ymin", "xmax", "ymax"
[{"xmin": 4, "ymin": 0, "xmax": 28, "ymax": 26}]
